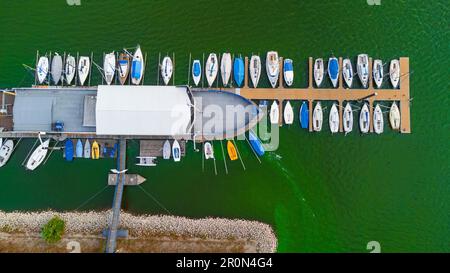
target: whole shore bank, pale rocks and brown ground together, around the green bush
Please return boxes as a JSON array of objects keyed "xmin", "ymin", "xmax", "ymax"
[{"xmin": 0, "ymin": 210, "xmax": 277, "ymax": 253}]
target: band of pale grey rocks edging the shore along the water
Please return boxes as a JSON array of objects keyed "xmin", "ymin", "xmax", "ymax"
[{"xmin": 0, "ymin": 210, "xmax": 277, "ymax": 253}]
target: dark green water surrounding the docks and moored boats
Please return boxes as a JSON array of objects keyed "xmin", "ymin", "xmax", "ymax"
[{"xmin": 0, "ymin": 0, "xmax": 450, "ymax": 252}]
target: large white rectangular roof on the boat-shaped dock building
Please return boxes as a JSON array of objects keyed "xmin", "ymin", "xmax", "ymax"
[{"xmin": 96, "ymin": 85, "xmax": 191, "ymax": 136}]
